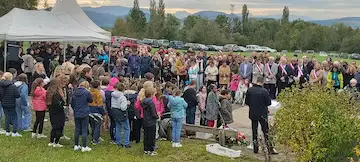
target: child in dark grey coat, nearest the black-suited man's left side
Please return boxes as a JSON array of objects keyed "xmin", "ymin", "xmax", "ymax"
[{"xmin": 220, "ymin": 90, "xmax": 234, "ymax": 128}]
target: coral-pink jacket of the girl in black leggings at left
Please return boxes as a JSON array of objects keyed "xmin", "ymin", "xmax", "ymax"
[{"xmin": 32, "ymin": 87, "xmax": 47, "ymax": 111}]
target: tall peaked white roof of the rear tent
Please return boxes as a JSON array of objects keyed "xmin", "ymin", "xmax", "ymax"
[{"xmin": 51, "ymin": 0, "xmax": 111, "ymax": 36}]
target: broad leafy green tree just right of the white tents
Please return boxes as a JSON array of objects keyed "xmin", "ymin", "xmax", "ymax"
[{"xmin": 126, "ymin": 0, "xmax": 146, "ymax": 38}]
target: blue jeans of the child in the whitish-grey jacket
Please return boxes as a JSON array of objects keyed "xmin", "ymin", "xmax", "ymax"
[{"xmin": 115, "ymin": 119, "xmax": 130, "ymax": 145}]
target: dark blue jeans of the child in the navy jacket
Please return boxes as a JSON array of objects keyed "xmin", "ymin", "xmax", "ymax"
[{"xmin": 74, "ymin": 116, "xmax": 89, "ymax": 147}]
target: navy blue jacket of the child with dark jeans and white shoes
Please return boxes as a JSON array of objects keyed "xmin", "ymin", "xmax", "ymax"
[{"xmin": 71, "ymin": 87, "xmax": 93, "ymax": 118}]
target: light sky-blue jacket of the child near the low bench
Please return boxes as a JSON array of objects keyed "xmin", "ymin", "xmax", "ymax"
[{"xmin": 168, "ymin": 96, "xmax": 188, "ymax": 118}]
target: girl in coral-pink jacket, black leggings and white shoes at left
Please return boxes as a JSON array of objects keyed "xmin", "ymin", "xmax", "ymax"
[{"xmin": 31, "ymin": 78, "xmax": 47, "ymax": 138}]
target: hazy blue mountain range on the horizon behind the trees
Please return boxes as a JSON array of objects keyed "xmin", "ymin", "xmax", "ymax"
[{"xmin": 82, "ymin": 6, "xmax": 360, "ymax": 28}]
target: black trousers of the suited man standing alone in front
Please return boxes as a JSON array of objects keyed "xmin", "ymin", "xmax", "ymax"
[{"xmin": 251, "ymin": 118, "xmax": 272, "ymax": 149}]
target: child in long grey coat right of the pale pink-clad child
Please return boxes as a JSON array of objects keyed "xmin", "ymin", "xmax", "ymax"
[{"xmin": 206, "ymin": 84, "xmax": 221, "ymax": 127}]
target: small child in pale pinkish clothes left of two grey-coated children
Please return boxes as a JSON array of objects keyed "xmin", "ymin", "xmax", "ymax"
[{"xmin": 196, "ymin": 86, "xmax": 207, "ymax": 126}]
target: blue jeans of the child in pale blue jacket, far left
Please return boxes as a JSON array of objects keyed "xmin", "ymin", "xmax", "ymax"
[{"xmin": 16, "ymin": 105, "xmax": 31, "ymax": 130}]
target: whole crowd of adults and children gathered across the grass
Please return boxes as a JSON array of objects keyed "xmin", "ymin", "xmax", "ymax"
[{"xmin": 0, "ymin": 42, "xmax": 360, "ymax": 155}]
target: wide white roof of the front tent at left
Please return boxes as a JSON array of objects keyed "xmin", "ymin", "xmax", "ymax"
[{"xmin": 0, "ymin": 8, "xmax": 111, "ymax": 42}]
